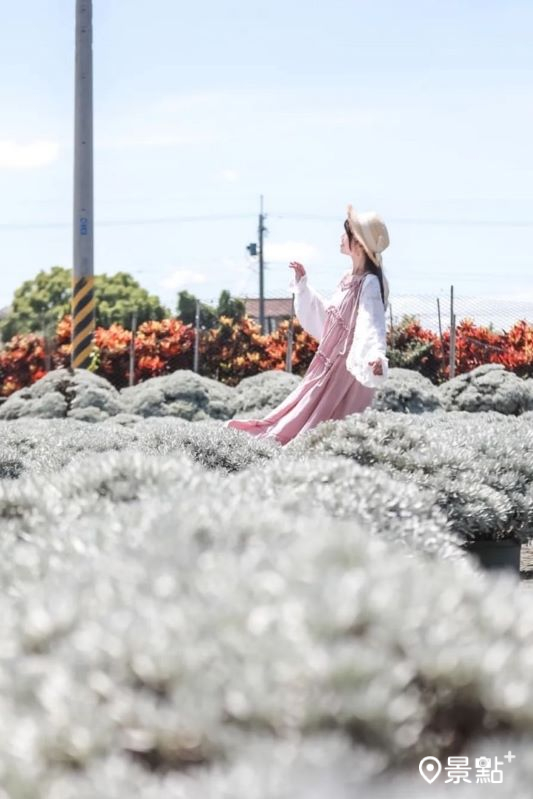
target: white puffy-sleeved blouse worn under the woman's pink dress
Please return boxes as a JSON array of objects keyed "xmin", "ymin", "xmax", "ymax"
[{"xmin": 289, "ymin": 273, "xmax": 389, "ymax": 388}]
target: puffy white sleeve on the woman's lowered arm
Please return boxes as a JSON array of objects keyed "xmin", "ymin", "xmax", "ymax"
[{"xmin": 346, "ymin": 275, "xmax": 389, "ymax": 388}]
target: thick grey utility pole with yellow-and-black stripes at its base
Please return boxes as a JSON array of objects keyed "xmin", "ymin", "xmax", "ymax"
[{"xmin": 70, "ymin": 0, "xmax": 95, "ymax": 369}]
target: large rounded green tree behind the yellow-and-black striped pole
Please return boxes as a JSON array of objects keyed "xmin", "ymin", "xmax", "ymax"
[{"xmin": 0, "ymin": 266, "xmax": 170, "ymax": 341}]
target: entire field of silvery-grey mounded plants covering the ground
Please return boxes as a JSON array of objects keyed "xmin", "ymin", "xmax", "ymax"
[{"xmin": 0, "ymin": 365, "xmax": 533, "ymax": 799}]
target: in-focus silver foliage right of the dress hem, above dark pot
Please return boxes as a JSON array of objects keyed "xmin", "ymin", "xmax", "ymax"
[{"xmin": 284, "ymin": 409, "xmax": 533, "ymax": 540}]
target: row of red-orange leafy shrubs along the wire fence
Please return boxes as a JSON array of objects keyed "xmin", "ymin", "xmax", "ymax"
[{"xmin": 0, "ymin": 315, "xmax": 533, "ymax": 396}]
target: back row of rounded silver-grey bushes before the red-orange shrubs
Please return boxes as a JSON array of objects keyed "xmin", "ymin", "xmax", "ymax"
[{"xmin": 0, "ymin": 364, "xmax": 533, "ymax": 424}]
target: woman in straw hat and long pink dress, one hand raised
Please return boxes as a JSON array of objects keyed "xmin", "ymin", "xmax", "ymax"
[{"xmin": 225, "ymin": 205, "xmax": 389, "ymax": 444}]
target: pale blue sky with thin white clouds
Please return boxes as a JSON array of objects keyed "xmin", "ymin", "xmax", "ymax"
[{"xmin": 0, "ymin": 0, "xmax": 533, "ymax": 328}]
